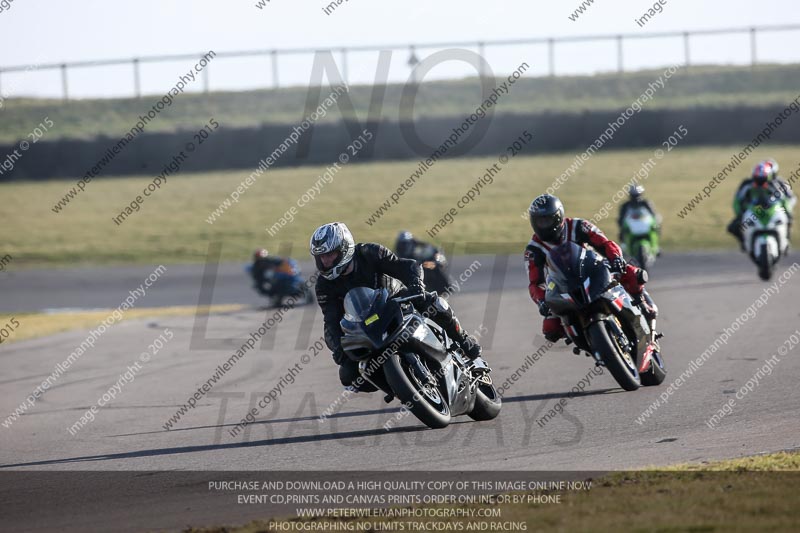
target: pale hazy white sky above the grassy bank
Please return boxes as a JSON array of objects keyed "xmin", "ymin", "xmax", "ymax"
[{"xmin": 0, "ymin": 0, "xmax": 800, "ymax": 96}]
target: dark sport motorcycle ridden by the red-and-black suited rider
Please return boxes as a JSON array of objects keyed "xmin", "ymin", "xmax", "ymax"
[{"xmin": 545, "ymin": 242, "xmax": 666, "ymax": 391}]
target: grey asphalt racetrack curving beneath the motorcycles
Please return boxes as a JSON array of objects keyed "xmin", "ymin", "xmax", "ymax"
[{"xmin": 0, "ymin": 253, "xmax": 800, "ymax": 531}]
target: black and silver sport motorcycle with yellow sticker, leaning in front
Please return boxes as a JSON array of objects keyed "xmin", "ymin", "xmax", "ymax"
[{"xmin": 340, "ymin": 287, "xmax": 501, "ymax": 428}]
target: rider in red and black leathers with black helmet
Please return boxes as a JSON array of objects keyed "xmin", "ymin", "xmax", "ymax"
[{"xmin": 525, "ymin": 194, "xmax": 658, "ymax": 342}]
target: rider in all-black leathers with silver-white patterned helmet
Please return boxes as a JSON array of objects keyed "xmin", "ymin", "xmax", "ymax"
[{"xmin": 310, "ymin": 222, "xmax": 481, "ymax": 392}]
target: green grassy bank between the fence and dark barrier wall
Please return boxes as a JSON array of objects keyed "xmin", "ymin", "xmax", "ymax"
[{"xmin": 0, "ymin": 65, "xmax": 800, "ymax": 143}]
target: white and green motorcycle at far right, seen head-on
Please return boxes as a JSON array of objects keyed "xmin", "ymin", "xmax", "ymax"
[{"xmin": 742, "ymin": 197, "xmax": 789, "ymax": 281}]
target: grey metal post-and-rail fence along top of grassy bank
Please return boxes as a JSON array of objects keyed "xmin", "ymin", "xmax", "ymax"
[{"xmin": 0, "ymin": 24, "xmax": 800, "ymax": 100}]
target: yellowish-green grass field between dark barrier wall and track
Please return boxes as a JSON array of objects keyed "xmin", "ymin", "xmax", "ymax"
[{"xmin": 0, "ymin": 144, "xmax": 800, "ymax": 270}]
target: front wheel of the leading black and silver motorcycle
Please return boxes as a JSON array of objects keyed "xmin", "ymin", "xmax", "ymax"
[{"xmin": 383, "ymin": 353, "xmax": 451, "ymax": 429}]
